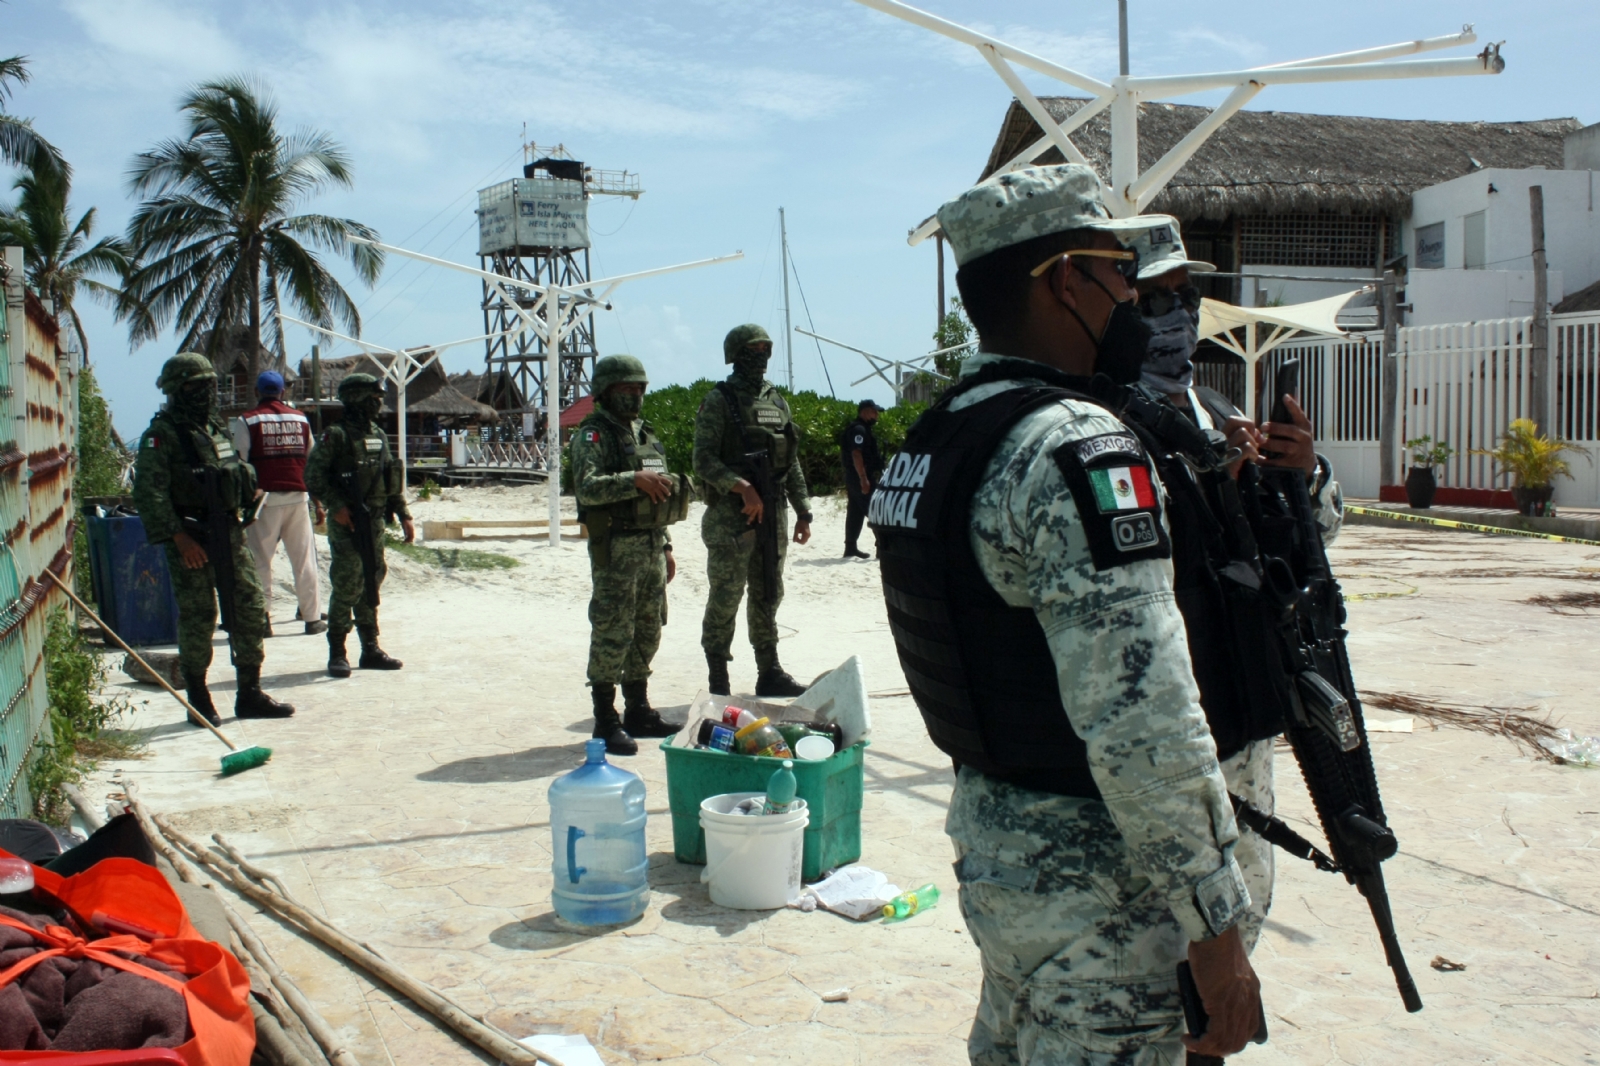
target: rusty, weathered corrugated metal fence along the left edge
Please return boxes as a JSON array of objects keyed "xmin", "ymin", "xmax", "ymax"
[{"xmin": 0, "ymin": 248, "xmax": 78, "ymax": 818}]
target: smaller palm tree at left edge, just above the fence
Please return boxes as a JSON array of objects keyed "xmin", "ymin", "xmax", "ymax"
[{"xmin": 0, "ymin": 160, "xmax": 128, "ymax": 362}]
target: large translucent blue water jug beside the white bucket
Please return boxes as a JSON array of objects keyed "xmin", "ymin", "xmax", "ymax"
[{"xmin": 550, "ymin": 739, "xmax": 650, "ymax": 925}]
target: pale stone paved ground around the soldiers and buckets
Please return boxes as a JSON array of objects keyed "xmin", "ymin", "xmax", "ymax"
[{"xmin": 90, "ymin": 490, "xmax": 1600, "ymax": 1066}]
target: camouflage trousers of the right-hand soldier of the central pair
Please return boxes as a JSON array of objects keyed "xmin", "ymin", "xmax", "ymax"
[{"xmin": 701, "ymin": 496, "xmax": 789, "ymax": 669}]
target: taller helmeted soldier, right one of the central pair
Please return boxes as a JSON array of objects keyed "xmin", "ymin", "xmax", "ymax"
[{"xmin": 694, "ymin": 325, "xmax": 811, "ymax": 696}]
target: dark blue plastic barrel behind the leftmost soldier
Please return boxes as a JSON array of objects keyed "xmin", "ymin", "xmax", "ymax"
[{"xmin": 83, "ymin": 507, "xmax": 178, "ymax": 647}]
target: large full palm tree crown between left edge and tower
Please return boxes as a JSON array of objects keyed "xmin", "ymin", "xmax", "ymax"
[{"xmin": 120, "ymin": 78, "xmax": 382, "ymax": 370}]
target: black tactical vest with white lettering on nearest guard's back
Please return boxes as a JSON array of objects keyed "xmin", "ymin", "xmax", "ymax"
[{"xmin": 867, "ymin": 373, "xmax": 1120, "ymax": 799}]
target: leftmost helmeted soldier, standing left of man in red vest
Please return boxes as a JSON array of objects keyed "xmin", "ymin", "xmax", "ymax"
[{"xmin": 133, "ymin": 352, "xmax": 294, "ymax": 725}]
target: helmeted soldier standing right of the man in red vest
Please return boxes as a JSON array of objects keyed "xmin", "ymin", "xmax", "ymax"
[{"xmin": 306, "ymin": 375, "xmax": 416, "ymax": 677}]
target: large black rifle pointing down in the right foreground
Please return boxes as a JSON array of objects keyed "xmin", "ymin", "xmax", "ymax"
[{"xmin": 1261, "ymin": 469, "xmax": 1422, "ymax": 1013}]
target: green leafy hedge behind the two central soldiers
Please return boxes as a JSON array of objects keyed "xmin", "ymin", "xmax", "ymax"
[{"xmin": 643, "ymin": 379, "xmax": 926, "ymax": 496}]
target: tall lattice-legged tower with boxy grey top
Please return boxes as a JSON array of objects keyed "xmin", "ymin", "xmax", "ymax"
[{"xmin": 478, "ymin": 142, "xmax": 643, "ymax": 434}]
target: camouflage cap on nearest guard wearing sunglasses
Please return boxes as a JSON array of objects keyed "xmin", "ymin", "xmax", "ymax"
[{"xmin": 939, "ymin": 163, "xmax": 1157, "ymax": 266}]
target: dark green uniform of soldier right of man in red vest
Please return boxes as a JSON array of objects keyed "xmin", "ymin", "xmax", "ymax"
[{"xmin": 306, "ymin": 416, "xmax": 411, "ymax": 633}]
